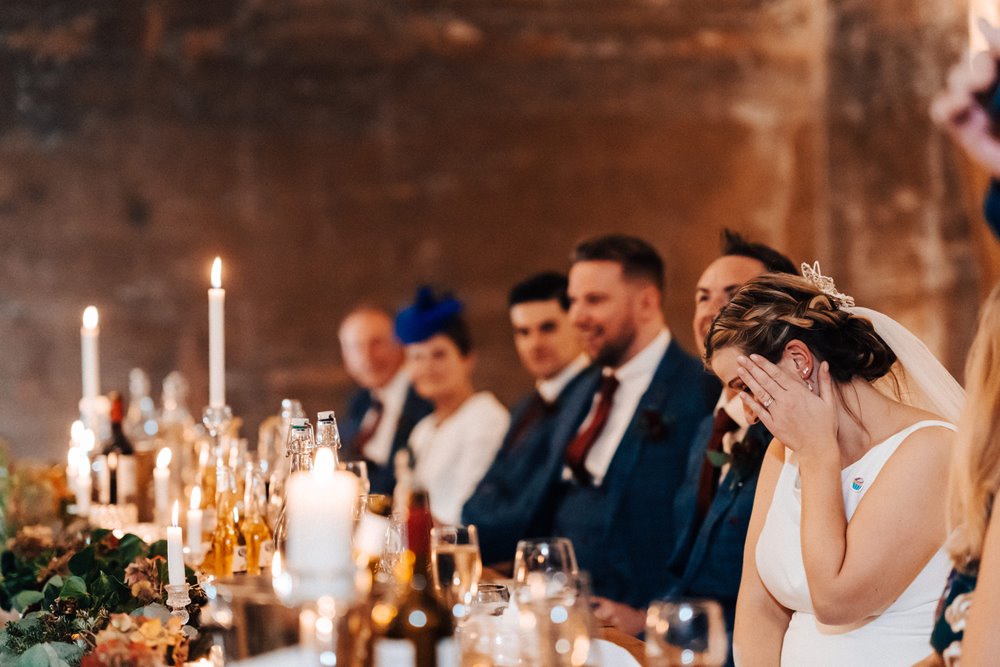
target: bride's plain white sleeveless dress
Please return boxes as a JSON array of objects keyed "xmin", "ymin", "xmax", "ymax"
[{"xmin": 756, "ymin": 420, "xmax": 954, "ymax": 667}]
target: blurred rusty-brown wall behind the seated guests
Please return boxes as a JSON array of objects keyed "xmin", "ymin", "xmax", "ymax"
[{"xmin": 0, "ymin": 0, "xmax": 1000, "ymax": 459}]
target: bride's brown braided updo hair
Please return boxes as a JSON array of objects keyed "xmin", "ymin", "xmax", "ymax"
[{"xmin": 705, "ymin": 273, "xmax": 896, "ymax": 382}]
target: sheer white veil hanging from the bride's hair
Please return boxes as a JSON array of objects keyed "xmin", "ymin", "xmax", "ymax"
[{"xmin": 802, "ymin": 262, "xmax": 965, "ymax": 424}]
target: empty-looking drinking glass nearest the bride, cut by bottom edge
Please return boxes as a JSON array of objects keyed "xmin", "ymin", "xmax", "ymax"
[{"xmin": 646, "ymin": 598, "xmax": 729, "ymax": 667}]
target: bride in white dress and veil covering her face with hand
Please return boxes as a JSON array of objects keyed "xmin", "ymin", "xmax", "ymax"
[{"xmin": 705, "ymin": 265, "xmax": 963, "ymax": 666}]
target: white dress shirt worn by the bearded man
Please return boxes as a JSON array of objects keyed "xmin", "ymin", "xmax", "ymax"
[{"xmin": 563, "ymin": 327, "xmax": 670, "ymax": 486}]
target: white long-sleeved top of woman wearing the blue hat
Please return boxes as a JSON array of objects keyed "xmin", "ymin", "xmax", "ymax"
[{"xmin": 410, "ymin": 391, "xmax": 510, "ymax": 525}]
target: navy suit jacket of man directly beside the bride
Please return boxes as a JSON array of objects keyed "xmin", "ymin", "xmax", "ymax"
[{"xmin": 666, "ymin": 415, "xmax": 771, "ymax": 662}]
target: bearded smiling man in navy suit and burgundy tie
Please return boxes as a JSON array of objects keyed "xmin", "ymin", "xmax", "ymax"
[{"xmin": 543, "ymin": 235, "xmax": 714, "ymax": 607}]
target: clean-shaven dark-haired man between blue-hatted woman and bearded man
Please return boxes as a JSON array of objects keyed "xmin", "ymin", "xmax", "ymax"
[{"xmin": 462, "ymin": 272, "xmax": 589, "ymax": 564}]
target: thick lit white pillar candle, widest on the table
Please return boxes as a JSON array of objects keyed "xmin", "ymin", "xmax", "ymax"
[{"xmin": 285, "ymin": 448, "xmax": 358, "ymax": 576}]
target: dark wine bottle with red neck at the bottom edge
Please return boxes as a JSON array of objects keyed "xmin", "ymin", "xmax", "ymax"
[{"xmin": 371, "ymin": 489, "xmax": 457, "ymax": 667}]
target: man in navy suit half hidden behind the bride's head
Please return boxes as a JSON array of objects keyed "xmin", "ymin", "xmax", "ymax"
[{"xmin": 595, "ymin": 229, "xmax": 796, "ymax": 664}]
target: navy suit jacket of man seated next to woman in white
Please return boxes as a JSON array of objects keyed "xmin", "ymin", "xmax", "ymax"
[{"xmin": 462, "ymin": 371, "xmax": 586, "ymax": 564}]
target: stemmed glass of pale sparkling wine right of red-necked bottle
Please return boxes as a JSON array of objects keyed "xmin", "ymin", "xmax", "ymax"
[{"xmin": 431, "ymin": 526, "xmax": 483, "ymax": 619}]
